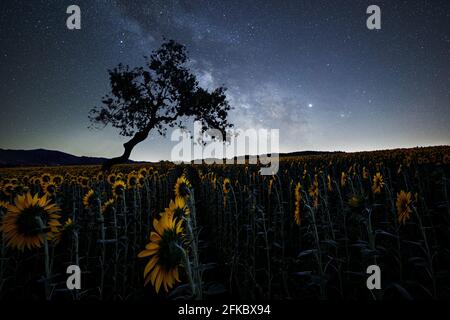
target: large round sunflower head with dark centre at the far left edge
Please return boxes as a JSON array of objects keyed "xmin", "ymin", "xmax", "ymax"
[{"xmin": 0, "ymin": 192, "xmax": 61, "ymax": 251}]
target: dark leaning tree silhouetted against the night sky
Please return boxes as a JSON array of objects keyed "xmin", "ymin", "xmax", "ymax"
[{"xmin": 89, "ymin": 40, "xmax": 233, "ymax": 171}]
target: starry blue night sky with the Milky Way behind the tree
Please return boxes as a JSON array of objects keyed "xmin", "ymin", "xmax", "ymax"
[{"xmin": 0, "ymin": 0, "xmax": 450, "ymax": 161}]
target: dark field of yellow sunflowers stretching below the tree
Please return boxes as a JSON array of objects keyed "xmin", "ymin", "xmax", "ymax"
[{"xmin": 0, "ymin": 147, "xmax": 450, "ymax": 300}]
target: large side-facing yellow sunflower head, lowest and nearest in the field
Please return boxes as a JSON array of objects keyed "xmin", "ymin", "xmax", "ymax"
[{"xmin": 138, "ymin": 212, "xmax": 183, "ymax": 293}]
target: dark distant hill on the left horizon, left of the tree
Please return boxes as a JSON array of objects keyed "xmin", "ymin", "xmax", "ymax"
[{"xmin": 0, "ymin": 149, "xmax": 128, "ymax": 167}]
